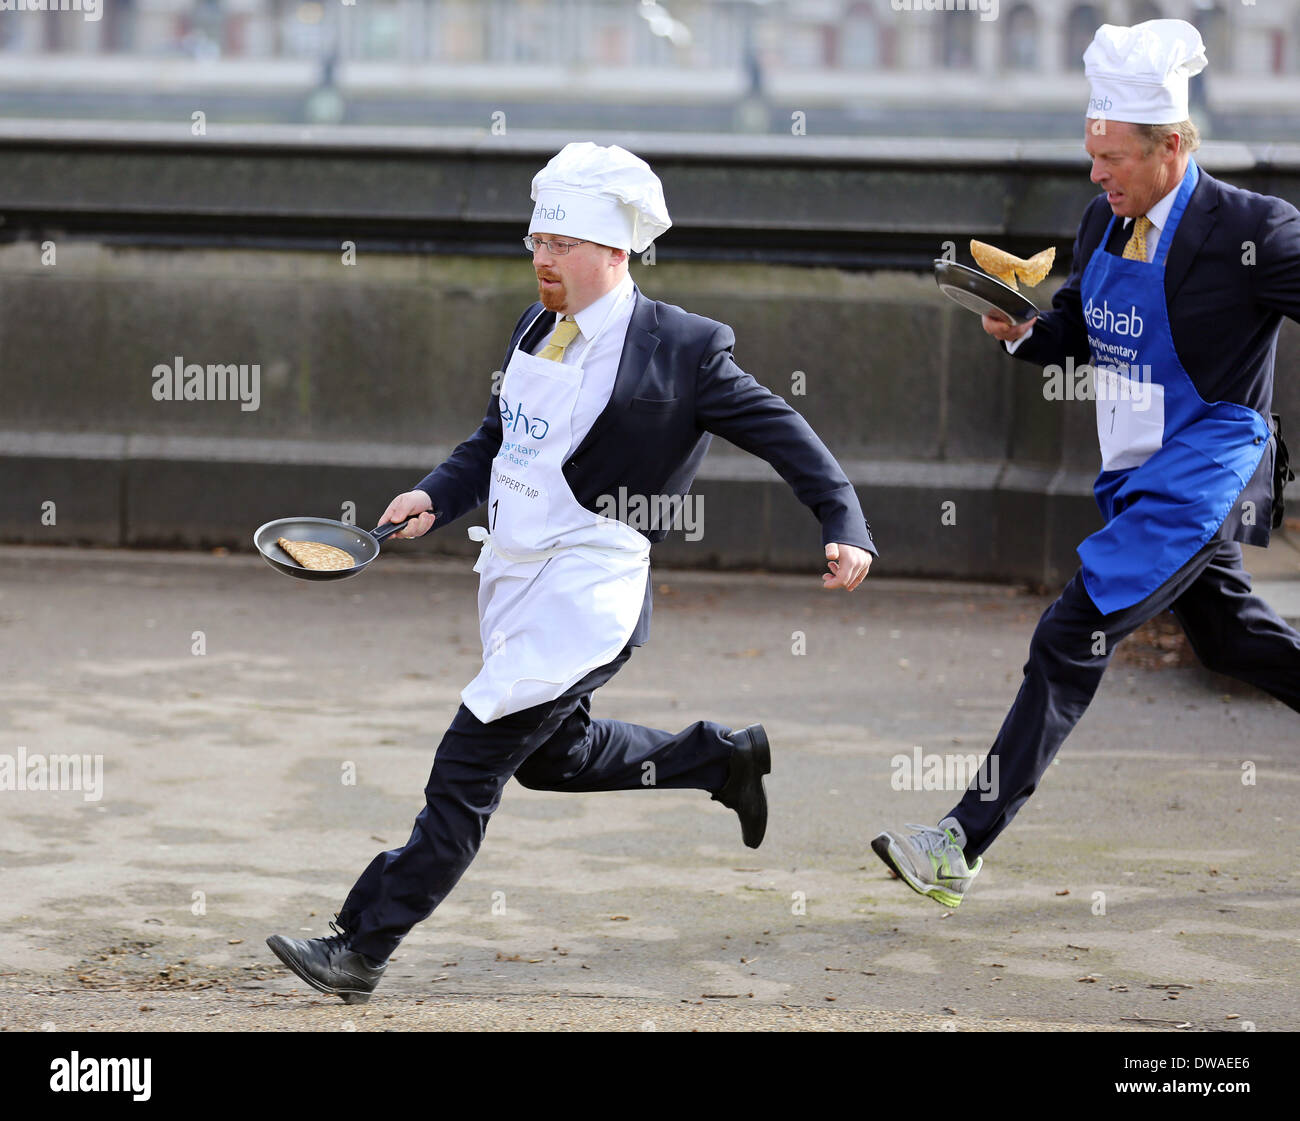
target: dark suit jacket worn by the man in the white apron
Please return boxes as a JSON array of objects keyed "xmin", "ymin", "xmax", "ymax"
[{"xmin": 417, "ymin": 290, "xmax": 876, "ymax": 645}]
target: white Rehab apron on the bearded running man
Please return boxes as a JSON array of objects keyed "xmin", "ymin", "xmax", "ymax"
[{"xmin": 460, "ymin": 299, "xmax": 650, "ymax": 723}]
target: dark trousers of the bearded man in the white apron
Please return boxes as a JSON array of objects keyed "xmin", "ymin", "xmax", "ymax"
[{"xmin": 338, "ymin": 646, "xmax": 733, "ymax": 960}]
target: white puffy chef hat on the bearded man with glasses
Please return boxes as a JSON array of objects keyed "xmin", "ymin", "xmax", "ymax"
[{"xmin": 528, "ymin": 140, "xmax": 672, "ymax": 252}]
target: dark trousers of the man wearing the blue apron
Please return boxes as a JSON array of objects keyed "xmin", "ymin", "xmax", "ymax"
[{"xmin": 952, "ymin": 540, "xmax": 1300, "ymax": 860}]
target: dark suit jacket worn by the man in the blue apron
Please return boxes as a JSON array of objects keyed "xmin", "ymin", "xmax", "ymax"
[{"xmin": 1015, "ymin": 168, "xmax": 1300, "ymax": 545}]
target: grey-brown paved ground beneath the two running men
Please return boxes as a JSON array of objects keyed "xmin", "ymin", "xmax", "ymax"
[{"xmin": 0, "ymin": 549, "xmax": 1300, "ymax": 1031}]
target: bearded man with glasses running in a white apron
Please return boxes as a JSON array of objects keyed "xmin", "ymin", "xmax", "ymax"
[{"xmin": 267, "ymin": 143, "xmax": 875, "ymax": 1003}]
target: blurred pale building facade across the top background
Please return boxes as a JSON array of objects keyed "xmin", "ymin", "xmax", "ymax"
[{"xmin": 0, "ymin": 0, "xmax": 1300, "ymax": 139}]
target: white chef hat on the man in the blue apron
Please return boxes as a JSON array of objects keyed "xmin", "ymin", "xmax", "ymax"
[{"xmin": 1083, "ymin": 20, "xmax": 1206, "ymax": 125}]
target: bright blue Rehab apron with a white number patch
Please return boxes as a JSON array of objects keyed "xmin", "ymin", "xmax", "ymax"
[{"xmin": 1079, "ymin": 160, "xmax": 1269, "ymax": 615}]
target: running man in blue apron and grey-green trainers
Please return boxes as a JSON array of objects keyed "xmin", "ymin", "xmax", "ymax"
[{"xmin": 871, "ymin": 20, "xmax": 1300, "ymax": 906}]
